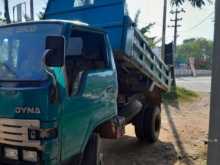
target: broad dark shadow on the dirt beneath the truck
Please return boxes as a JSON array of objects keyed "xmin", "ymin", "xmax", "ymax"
[{"xmin": 103, "ymin": 136, "xmax": 177, "ymax": 165}]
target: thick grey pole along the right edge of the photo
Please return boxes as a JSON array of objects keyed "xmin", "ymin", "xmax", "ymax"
[{"xmin": 208, "ymin": 0, "xmax": 220, "ymax": 165}]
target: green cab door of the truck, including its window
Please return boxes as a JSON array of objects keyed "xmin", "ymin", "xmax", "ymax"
[{"xmin": 61, "ymin": 29, "xmax": 117, "ymax": 160}]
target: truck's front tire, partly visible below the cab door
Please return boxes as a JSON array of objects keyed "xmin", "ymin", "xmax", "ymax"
[{"xmin": 81, "ymin": 134, "xmax": 103, "ymax": 165}]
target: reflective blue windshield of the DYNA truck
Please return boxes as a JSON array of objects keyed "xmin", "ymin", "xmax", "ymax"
[{"xmin": 0, "ymin": 24, "xmax": 62, "ymax": 81}]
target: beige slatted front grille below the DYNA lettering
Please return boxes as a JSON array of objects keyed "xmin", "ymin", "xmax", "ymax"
[{"xmin": 0, "ymin": 119, "xmax": 41, "ymax": 150}]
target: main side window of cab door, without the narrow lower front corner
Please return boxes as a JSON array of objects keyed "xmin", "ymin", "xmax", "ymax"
[{"xmin": 66, "ymin": 30, "xmax": 108, "ymax": 70}]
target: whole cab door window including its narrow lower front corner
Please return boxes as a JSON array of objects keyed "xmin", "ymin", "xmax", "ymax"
[{"xmin": 65, "ymin": 30, "xmax": 108, "ymax": 96}]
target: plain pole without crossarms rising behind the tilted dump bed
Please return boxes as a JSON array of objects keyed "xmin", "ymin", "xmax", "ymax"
[{"xmin": 161, "ymin": 0, "xmax": 167, "ymax": 60}]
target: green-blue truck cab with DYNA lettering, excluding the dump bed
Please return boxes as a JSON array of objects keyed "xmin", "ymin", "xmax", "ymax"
[{"xmin": 0, "ymin": 20, "xmax": 118, "ymax": 165}]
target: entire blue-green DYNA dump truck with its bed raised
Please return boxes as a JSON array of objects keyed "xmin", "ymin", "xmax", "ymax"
[{"xmin": 0, "ymin": 0, "xmax": 171, "ymax": 165}]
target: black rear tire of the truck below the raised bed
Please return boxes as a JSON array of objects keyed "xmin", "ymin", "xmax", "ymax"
[{"xmin": 134, "ymin": 106, "xmax": 161, "ymax": 143}]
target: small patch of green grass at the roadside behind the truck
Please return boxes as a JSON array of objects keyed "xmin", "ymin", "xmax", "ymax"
[{"xmin": 162, "ymin": 87, "xmax": 199, "ymax": 103}]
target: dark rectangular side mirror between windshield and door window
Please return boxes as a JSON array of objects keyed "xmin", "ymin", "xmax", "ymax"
[{"xmin": 44, "ymin": 36, "xmax": 65, "ymax": 67}]
